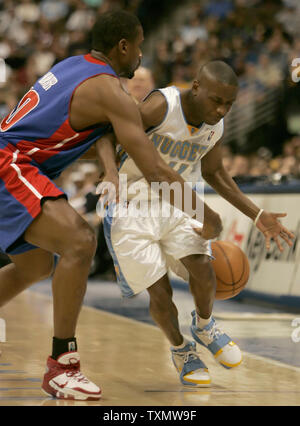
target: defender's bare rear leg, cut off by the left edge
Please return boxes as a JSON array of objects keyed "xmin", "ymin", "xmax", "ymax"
[{"xmin": 0, "ymin": 249, "xmax": 54, "ymax": 307}]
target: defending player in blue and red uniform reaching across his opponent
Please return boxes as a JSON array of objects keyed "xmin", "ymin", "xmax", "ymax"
[{"xmin": 0, "ymin": 11, "xmax": 221, "ymax": 400}]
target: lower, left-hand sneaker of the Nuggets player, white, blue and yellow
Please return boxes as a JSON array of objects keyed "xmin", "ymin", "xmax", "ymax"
[{"xmin": 171, "ymin": 342, "xmax": 210, "ymax": 387}]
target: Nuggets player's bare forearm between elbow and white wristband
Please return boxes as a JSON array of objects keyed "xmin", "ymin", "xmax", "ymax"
[{"xmin": 203, "ymin": 168, "xmax": 260, "ymax": 220}]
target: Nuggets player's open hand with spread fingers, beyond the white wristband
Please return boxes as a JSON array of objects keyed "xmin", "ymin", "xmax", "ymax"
[{"xmin": 256, "ymin": 211, "xmax": 295, "ymax": 252}]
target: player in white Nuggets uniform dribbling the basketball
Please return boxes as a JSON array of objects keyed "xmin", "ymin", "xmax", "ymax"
[{"xmin": 98, "ymin": 61, "xmax": 293, "ymax": 387}]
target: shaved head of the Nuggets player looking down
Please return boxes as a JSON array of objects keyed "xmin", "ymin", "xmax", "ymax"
[{"xmin": 191, "ymin": 61, "xmax": 238, "ymax": 125}]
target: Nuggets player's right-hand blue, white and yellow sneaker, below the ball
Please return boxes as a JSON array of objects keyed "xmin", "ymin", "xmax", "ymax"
[{"xmin": 191, "ymin": 311, "xmax": 242, "ymax": 369}]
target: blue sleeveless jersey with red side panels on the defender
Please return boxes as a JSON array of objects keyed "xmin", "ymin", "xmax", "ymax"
[{"xmin": 0, "ymin": 54, "xmax": 118, "ymax": 179}]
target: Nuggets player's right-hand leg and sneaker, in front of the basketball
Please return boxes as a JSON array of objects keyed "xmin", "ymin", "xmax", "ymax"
[{"xmin": 181, "ymin": 254, "xmax": 242, "ymax": 368}]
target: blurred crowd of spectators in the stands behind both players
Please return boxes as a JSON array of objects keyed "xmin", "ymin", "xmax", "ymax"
[{"xmin": 0, "ymin": 0, "xmax": 300, "ymax": 273}]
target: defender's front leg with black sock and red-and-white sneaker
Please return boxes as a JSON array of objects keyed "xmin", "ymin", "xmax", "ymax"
[{"xmin": 21, "ymin": 198, "xmax": 101, "ymax": 400}]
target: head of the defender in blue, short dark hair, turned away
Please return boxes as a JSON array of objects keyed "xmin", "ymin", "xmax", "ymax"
[{"xmin": 92, "ymin": 10, "xmax": 144, "ymax": 78}]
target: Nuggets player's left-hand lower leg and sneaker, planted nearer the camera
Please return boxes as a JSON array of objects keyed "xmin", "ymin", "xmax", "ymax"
[{"xmin": 147, "ymin": 275, "xmax": 210, "ymax": 387}]
